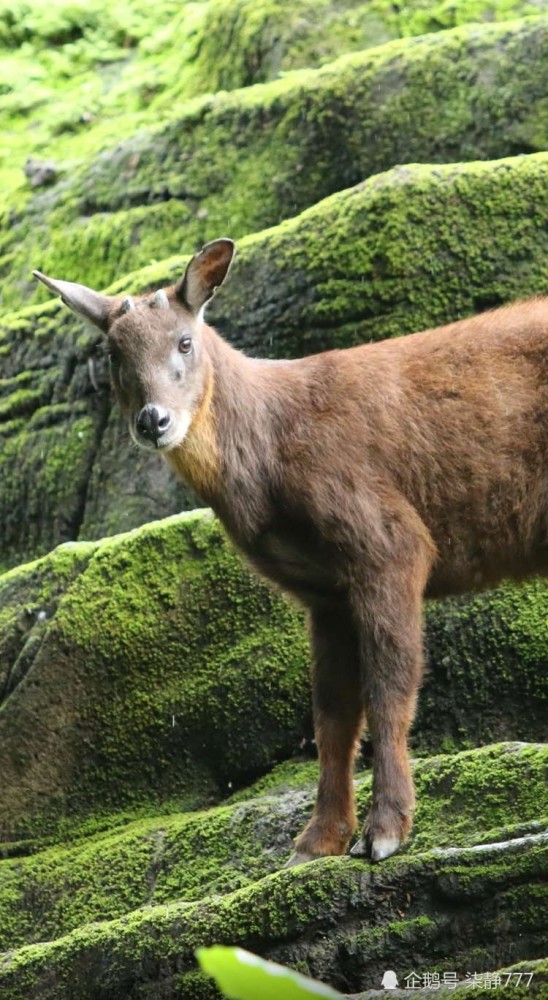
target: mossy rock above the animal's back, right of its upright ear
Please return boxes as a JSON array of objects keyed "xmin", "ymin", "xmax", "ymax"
[{"xmin": 206, "ymin": 154, "xmax": 548, "ymax": 357}]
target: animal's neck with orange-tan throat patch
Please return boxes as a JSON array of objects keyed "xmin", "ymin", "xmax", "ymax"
[{"xmin": 167, "ymin": 327, "xmax": 273, "ymax": 534}]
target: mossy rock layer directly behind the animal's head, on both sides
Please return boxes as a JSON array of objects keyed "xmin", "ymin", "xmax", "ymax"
[{"xmin": 0, "ymin": 154, "xmax": 548, "ymax": 565}]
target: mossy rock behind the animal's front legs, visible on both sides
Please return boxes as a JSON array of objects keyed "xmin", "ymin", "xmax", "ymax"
[{"xmin": 0, "ymin": 512, "xmax": 548, "ymax": 841}]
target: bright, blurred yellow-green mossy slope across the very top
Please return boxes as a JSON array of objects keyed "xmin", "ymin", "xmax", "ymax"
[{"xmin": 0, "ymin": 0, "xmax": 547, "ymax": 215}]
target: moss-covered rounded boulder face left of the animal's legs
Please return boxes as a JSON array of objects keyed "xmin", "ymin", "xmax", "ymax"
[{"xmin": 0, "ymin": 514, "xmax": 307, "ymax": 839}]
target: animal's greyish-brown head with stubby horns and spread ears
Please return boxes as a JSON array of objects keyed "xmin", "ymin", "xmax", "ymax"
[{"xmin": 33, "ymin": 239, "xmax": 234, "ymax": 450}]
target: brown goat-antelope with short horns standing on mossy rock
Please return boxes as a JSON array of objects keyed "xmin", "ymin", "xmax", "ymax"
[{"xmin": 34, "ymin": 239, "xmax": 548, "ymax": 862}]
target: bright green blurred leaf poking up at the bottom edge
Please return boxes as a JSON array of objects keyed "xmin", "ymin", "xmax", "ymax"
[{"xmin": 196, "ymin": 945, "xmax": 342, "ymax": 1000}]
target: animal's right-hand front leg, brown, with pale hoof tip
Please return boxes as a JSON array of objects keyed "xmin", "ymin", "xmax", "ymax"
[{"xmin": 352, "ymin": 565, "xmax": 424, "ymax": 861}]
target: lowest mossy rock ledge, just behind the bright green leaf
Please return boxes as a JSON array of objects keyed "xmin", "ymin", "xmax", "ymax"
[{"xmin": 0, "ymin": 840, "xmax": 546, "ymax": 1000}]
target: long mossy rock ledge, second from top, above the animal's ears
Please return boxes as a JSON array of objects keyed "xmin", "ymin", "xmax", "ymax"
[{"xmin": 4, "ymin": 11, "xmax": 548, "ymax": 309}]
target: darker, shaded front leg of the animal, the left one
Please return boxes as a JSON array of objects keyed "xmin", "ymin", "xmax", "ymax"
[{"xmin": 289, "ymin": 607, "xmax": 363, "ymax": 864}]
